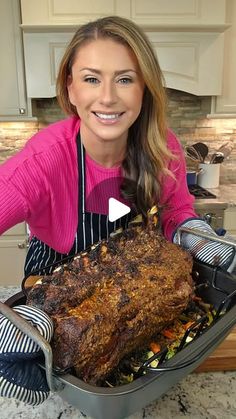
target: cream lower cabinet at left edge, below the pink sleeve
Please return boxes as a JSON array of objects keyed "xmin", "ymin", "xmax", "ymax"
[{"xmin": 0, "ymin": 223, "xmax": 28, "ymax": 286}]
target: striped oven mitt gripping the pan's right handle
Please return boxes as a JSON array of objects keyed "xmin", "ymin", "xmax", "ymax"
[{"xmin": 173, "ymin": 218, "xmax": 235, "ymax": 271}]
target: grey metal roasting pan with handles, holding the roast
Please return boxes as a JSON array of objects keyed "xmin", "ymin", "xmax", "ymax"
[{"xmin": 0, "ymin": 228, "xmax": 236, "ymax": 419}]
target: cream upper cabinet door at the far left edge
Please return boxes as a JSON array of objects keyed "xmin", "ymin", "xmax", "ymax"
[{"xmin": 0, "ymin": 0, "xmax": 27, "ymax": 119}]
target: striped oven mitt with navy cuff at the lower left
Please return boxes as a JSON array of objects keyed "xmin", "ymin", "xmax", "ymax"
[{"xmin": 0, "ymin": 305, "xmax": 53, "ymax": 405}]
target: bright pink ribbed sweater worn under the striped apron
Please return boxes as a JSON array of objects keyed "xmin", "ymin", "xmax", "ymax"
[{"xmin": 0, "ymin": 117, "xmax": 196, "ymax": 253}]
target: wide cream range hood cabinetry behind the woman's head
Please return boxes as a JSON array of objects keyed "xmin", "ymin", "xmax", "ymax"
[{"xmin": 21, "ymin": 0, "xmax": 229, "ymax": 97}]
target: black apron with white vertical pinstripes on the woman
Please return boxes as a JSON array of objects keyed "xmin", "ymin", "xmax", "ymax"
[{"xmin": 24, "ymin": 134, "xmax": 135, "ymax": 276}]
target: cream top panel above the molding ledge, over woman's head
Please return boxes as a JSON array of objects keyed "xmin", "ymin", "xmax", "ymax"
[{"xmin": 21, "ymin": 0, "xmax": 225, "ymax": 28}]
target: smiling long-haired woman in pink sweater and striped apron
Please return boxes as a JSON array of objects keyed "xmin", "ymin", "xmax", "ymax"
[{"xmin": 0, "ymin": 17, "xmax": 234, "ymax": 403}]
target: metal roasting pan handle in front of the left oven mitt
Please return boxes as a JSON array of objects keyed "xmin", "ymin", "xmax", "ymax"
[{"xmin": 0, "ymin": 302, "xmax": 62, "ymax": 392}]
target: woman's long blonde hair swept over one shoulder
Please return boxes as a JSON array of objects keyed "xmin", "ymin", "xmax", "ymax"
[{"xmin": 57, "ymin": 16, "xmax": 173, "ymax": 216}]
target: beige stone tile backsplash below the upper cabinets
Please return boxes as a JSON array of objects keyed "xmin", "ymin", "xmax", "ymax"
[{"xmin": 0, "ymin": 89, "xmax": 236, "ymax": 184}]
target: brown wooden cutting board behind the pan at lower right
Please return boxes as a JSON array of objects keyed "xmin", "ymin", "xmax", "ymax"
[{"xmin": 195, "ymin": 327, "xmax": 236, "ymax": 372}]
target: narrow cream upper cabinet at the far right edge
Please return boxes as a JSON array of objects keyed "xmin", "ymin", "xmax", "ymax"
[{"xmin": 211, "ymin": 0, "xmax": 236, "ymax": 118}]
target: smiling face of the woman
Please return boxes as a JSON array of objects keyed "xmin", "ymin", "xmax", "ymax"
[{"xmin": 68, "ymin": 39, "xmax": 144, "ymax": 146}]
